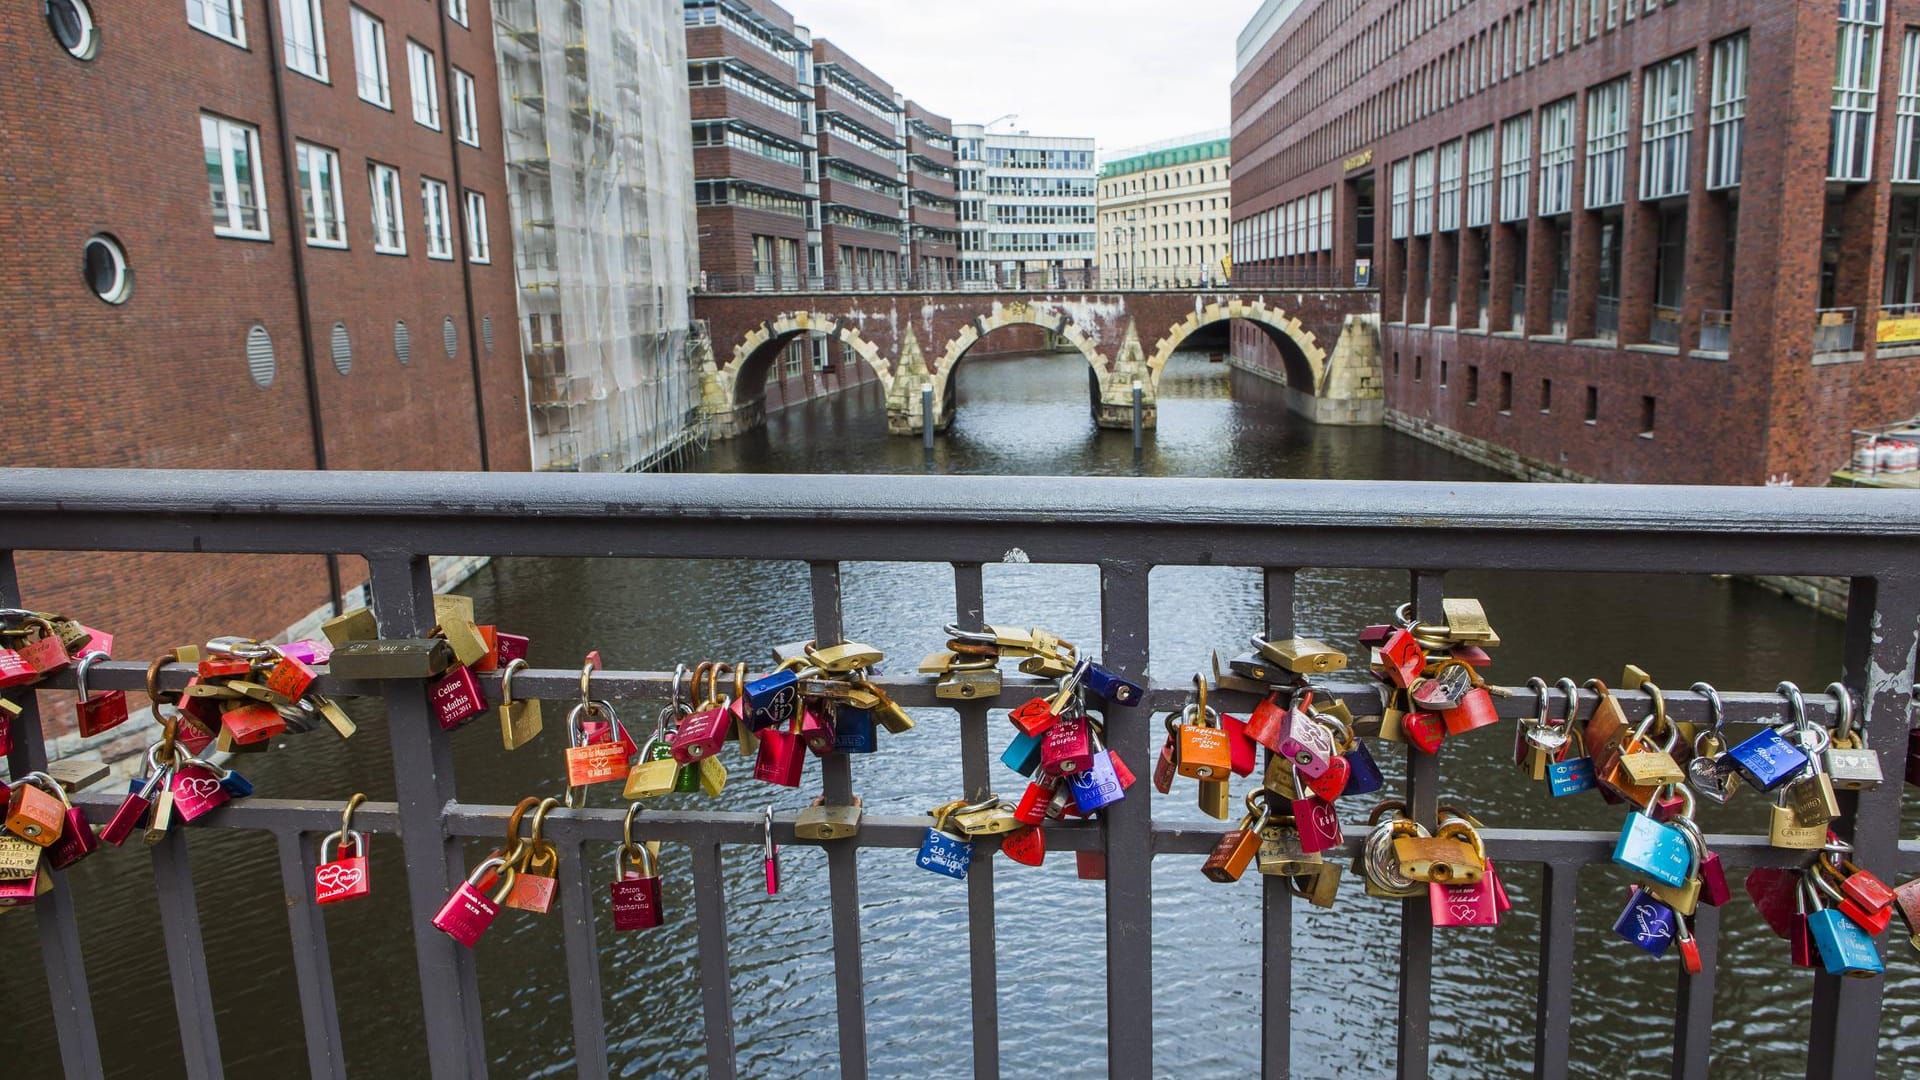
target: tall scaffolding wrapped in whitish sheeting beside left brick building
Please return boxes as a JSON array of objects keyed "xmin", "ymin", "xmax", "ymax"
[{"xmin": 493, "ymin": 0, "xmax": 699, "ymax": 473}]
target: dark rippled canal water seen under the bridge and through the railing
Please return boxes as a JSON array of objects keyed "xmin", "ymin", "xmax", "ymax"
[{"xmin": 0, "ymin": 356, "xmax": 1920, "ymax": 1076}]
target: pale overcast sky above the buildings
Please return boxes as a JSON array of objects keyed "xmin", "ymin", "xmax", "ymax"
[{"xmin": 781, "ymin": 0, "xmax": 1260, "ymax": 152}]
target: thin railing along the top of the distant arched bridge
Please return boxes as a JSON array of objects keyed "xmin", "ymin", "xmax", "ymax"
[{"xmin": 699, "ymin": 267, "xmax": 1352, "ymax": 294}]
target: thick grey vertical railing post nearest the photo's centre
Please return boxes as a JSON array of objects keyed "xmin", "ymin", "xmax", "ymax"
[{"xmin": 1100, "ymin": 561, "xmax": 1154, "ymax": 1080}]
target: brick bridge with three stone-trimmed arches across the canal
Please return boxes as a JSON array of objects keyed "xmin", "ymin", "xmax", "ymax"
[{"xmin": 693, "ymin": 288, "xmax": 1382, "ymax": 438}]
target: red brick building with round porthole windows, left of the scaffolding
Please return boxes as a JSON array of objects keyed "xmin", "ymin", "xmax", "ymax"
[{"xmin": 0, "ymin": 0, "xmax": 528, "ymax": 655}]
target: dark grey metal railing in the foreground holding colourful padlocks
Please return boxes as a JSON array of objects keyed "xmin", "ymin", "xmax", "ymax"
[{"xmin": 0, "ymin": 469, "xmax": 1920, "ymax": 1078}]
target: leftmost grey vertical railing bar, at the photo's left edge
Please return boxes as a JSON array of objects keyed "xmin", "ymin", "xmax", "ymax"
[{"xmin": 0, "ymin": 548, "xmax": 106, "ymax": 1078}]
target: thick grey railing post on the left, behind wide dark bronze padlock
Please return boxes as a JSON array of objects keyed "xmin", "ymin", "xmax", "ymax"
[{"xmin": 367, "ymin": 553, "xmax": 488, "ymax": 1080}]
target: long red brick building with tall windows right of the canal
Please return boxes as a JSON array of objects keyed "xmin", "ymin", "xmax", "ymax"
[{"xmin": 1233, "ymin": 0, "xmax": 1920, "ymax": 484}]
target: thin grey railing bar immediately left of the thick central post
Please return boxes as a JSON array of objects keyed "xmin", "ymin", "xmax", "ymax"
[{"xmin": 954, "ymin": 563, "xmax": 998, "ymax": 1080}]
